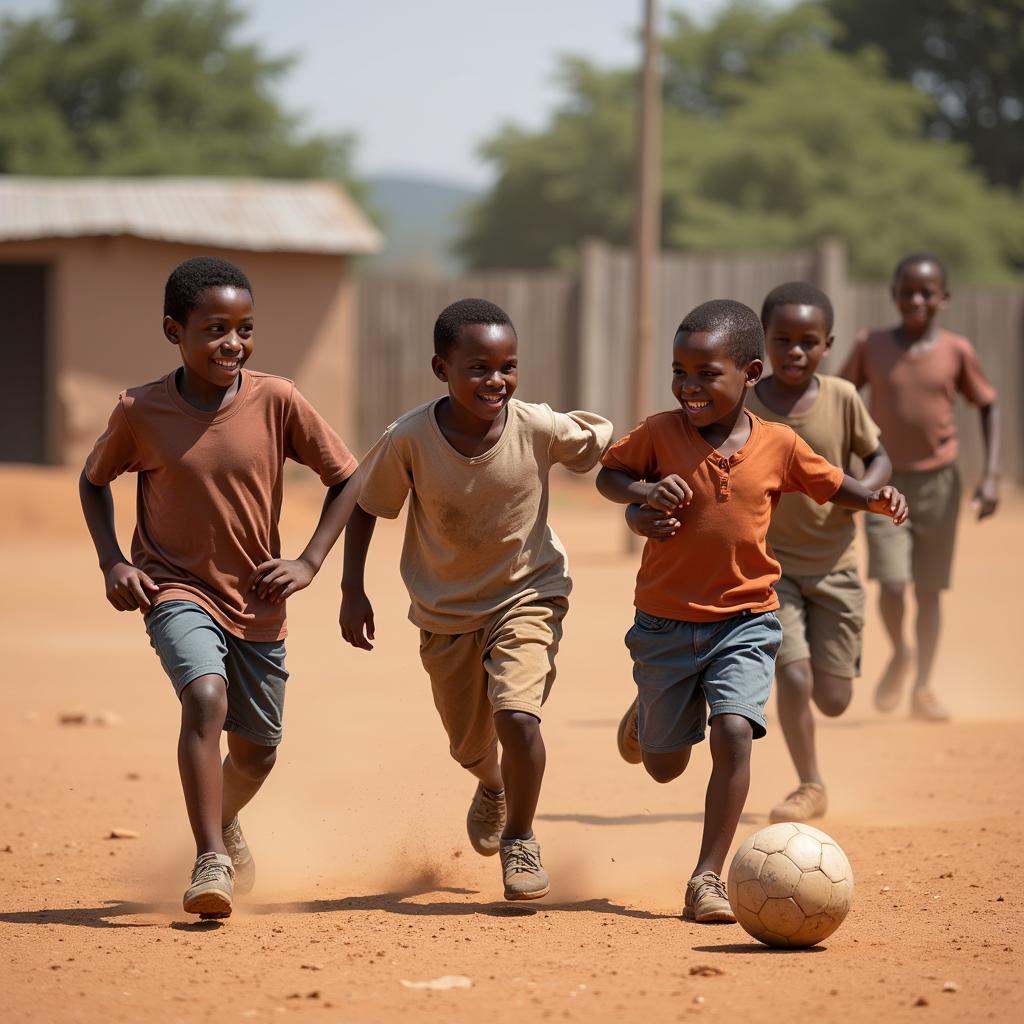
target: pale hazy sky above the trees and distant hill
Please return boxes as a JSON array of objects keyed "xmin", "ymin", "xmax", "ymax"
[{"xmin": 0, "ymin": 0, "xmax": 770, "ymax": 185}]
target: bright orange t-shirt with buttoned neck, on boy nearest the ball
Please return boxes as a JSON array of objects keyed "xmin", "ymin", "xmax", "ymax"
[{"xmin": 601, "ymin": 410, "xmax": 844, "ymax": 623}]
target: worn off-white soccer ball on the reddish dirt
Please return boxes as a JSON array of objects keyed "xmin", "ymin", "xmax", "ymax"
[{"xmin": 729, "ymin": 821, "xmax": 853, "ymax": 947}]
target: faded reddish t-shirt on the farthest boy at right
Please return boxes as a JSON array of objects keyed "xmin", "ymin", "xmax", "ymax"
[{"xmin": 840, "ymin": 330, "xmax": 995, "ymax": 472}]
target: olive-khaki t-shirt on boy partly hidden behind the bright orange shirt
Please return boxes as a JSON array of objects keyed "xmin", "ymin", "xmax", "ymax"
[{"xmin": 746, "ymin": 374, "xmax": 879, "ymax": 575}]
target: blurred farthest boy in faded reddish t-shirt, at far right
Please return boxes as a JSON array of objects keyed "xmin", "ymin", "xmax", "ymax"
[{"xmin": 841, "ymin": 252, "xmax": 999, "ymax": 722}]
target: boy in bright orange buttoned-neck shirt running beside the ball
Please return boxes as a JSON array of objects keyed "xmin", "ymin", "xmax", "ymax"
[{"xmin": 597, "ymin": 299, "xmax": 906, "ymax": 922}]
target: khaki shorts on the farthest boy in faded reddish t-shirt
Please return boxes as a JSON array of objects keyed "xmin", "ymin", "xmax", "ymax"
[{"xmin": 867, "ymin": 466, "xmax": 961, "ymax": 591}]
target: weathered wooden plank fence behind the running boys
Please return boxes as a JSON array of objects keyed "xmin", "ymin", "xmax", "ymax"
[{"xmin": 355, "ymin": 241, "xmax": 1024, "ymax": 483}]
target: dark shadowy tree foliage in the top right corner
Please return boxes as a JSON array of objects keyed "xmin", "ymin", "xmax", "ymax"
[{"xmin": 824, "ymin": 0, "xmax": 1024, "ymax": 185}]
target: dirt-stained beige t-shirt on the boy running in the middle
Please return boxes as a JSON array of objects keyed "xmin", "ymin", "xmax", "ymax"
[{"xmin": 359, "ymin": 398, "xmax": 611, "ymax": 634}]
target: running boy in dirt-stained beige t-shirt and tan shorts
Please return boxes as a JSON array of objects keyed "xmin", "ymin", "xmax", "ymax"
[{"xmin": 340, "ymin": 299, "xmax": 611, "ymax": 900}]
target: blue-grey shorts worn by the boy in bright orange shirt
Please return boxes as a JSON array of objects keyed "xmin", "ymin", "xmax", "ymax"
[{"xmin": 626, "ymin": 608, "xmax": 782, "ymax": 754}]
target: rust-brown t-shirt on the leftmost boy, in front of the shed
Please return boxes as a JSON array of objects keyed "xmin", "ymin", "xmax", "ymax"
[{"xmin": 85, "ymin": 370, "xmax": 356, "ymax": 642}]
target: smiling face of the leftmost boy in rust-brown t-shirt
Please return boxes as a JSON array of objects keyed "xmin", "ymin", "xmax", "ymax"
[{"xmin": 164, "ymin": 286, "xmax": 253, "ymax": 397}]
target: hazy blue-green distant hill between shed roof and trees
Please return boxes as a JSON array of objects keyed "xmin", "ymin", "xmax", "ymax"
[{"xmin": 369, "ymin": 174, "xmax": 480, "ymax": 274}]
